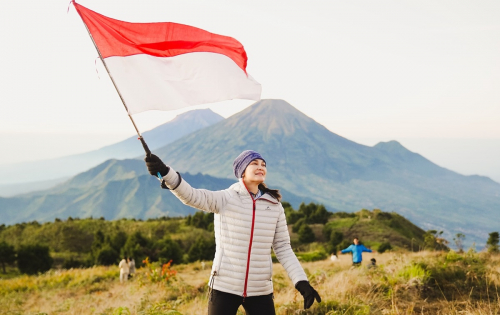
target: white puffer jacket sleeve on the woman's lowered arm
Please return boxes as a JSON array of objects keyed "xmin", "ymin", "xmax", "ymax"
[{"xmin": 273, "ymin": 205, "xmax": 307, "ymax": 286}]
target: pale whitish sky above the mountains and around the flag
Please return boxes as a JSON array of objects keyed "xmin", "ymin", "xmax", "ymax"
[{"xmin": 0, "ymin": 0, "xmax": 500, "ymax": 182}]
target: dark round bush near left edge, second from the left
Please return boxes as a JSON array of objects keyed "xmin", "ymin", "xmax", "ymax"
[{"xmin": 17, "ymin": 244, "xmax": 54, "ymax": 275}]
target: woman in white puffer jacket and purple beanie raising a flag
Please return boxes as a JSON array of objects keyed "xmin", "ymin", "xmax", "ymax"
[{"xmin": 144, "ymin": 150, "xmax": 321, "ymax": 315}]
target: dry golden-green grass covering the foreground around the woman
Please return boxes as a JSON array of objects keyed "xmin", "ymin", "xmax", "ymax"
[{"xmin": 0, "ymin": 252, "xmax": 500, "ymax": 315}]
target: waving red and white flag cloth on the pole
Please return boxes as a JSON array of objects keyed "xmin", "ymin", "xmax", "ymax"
[{"xmin": 73, "ymin": 1, "xmax": 262, "ymax": 115}]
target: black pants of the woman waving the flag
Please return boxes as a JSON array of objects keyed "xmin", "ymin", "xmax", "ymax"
[{"xmin": 208, "ymin": 290, "xmax": 276, "ymax": 315}]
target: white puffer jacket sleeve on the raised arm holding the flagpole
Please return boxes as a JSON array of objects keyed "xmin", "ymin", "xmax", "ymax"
[{"xmin": 163, "ymin": 167, "xmax": 231, "ymax": 213}]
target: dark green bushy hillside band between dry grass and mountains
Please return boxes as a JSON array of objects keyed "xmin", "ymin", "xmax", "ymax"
[{"xmin": 0, "ymin": 210, "xmax": 435, "ymax": 272}]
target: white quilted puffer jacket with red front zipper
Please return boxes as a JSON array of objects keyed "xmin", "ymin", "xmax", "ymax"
[{"xmin": 163, "ymin": 168, "xmax": 307, "ymax": 297}]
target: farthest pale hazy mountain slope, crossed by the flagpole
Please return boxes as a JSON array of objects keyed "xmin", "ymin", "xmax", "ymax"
[{"xmin": 0, "ymin": 109, "xmax": 224, "ymax": 191}]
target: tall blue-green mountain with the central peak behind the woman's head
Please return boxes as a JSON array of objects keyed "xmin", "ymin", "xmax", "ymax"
[{"xmin": 155, "ymin": 100, "xmax": 500, "ymax": 246}]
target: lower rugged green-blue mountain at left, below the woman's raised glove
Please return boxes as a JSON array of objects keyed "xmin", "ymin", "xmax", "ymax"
[{"xmin": 0, "ymin": 160, "xmax": 311, "ymax": 224}]
